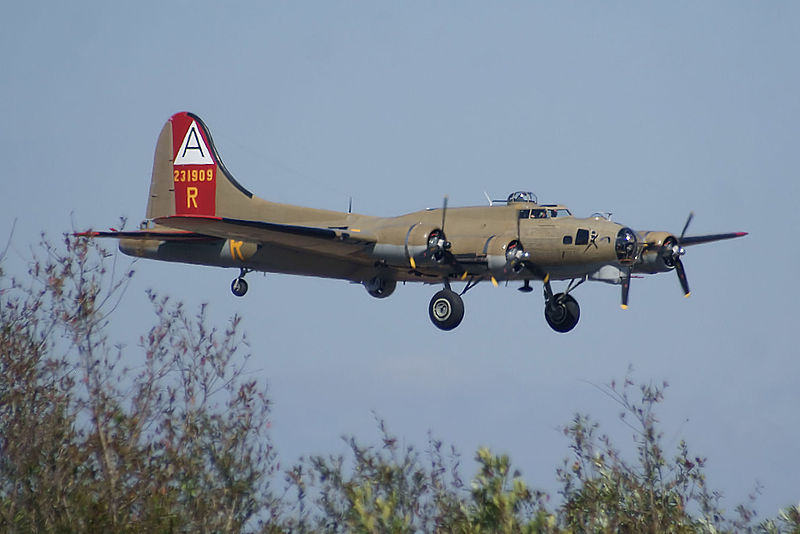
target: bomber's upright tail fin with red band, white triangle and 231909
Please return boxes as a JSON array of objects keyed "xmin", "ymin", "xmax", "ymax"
[{"xmin": 147, "ymin": 111, "xmax": 253, "ymax": 219}]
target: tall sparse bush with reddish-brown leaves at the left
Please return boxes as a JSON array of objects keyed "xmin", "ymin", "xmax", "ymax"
[{"xmin": 0, "ymin": 237, "xmax": 277, "ymax": 532}]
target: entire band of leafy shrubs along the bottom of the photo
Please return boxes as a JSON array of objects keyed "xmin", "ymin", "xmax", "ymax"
[{"xmin": 0, "ymin": 236, "xmax": 800, "ymax": 534}]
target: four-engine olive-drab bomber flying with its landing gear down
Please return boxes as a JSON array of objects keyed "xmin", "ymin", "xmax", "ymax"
[{"xmin": 78, "ymin": 112, "xmax": 747, "ymax": 333}]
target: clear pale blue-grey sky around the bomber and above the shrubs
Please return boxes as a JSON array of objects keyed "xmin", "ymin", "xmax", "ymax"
[{"xmin": 0, "ymin": 1, "xmax": 800, "ymax": 518}]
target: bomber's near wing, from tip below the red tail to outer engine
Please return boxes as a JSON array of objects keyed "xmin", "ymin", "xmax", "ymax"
[{"xmin": 156, "ymin": 215, "xmax": 376, "ymax": 256}]
